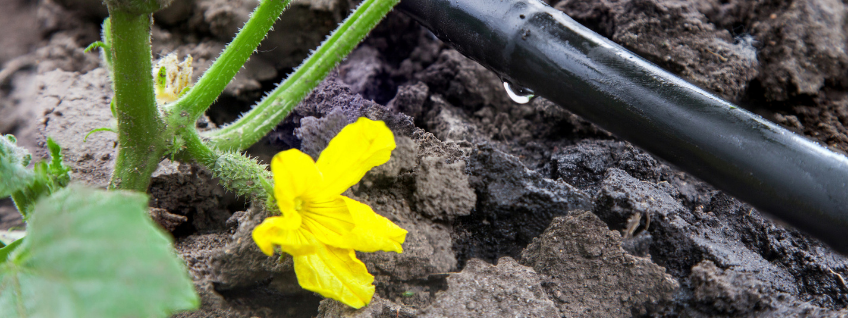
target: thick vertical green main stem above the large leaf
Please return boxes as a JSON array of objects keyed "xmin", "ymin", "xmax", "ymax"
[{"xmin": 109, "ymin": 7, "xmax": 165, "ymax": 192}]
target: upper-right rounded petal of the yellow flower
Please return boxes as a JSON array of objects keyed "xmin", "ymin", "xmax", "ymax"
[{"xmin": 317, "ymin": 117, "xmax": 395, "ymax": 195}]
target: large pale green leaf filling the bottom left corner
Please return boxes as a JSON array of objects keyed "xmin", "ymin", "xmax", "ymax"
[{"xmin": 0, "ymin": 185, "xmax": 199, "ymax": 318}]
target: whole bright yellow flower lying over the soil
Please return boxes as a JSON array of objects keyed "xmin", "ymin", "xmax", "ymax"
[{"xmin": 253, "ymin": 118, "xmax": 407, "ymax": 308}]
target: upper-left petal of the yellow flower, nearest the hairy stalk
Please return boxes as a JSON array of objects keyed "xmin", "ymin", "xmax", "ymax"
[{"xmin": 271, "ymin": 149, "xmax": 324, "ymax": 214}]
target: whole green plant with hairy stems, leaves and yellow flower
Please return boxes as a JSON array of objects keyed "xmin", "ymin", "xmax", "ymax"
[{"xmin": 0, "ymin": 0, "xmax": 406, "ymax": 317}]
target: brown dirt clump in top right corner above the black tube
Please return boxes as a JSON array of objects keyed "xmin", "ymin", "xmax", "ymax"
[{"xmin": 703, "ymin": 0, "xmax": 848, "ymax": 101}]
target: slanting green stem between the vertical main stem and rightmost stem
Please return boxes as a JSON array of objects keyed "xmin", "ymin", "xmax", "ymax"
[{"xmin": 169, "ymin": 0, "xmax": 291, "ymax": 124}]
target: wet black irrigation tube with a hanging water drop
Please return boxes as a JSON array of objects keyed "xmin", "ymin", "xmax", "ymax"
[{"xmin": 397, "ymin": 0, "xmax": 848, "ymax": 254}]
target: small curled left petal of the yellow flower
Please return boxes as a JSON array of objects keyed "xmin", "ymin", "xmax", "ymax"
[{"xmin": 252, "ymin": 213, "xmax": 323, "ymax": 256}]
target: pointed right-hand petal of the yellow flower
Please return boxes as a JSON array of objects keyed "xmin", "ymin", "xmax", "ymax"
[{"xmin": 342, "ymin": 196, "xmax": 407, "ymax": 253}]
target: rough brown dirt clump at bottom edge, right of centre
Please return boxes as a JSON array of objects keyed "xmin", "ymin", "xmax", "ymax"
[{"xmin": 521, "ymin": 211, "xmax": 678, "ymax": 317}]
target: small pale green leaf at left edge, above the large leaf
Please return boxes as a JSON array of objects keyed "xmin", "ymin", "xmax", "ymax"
[{"xmin": 0, "ymin": 135, "xmax": 35, "ymax": 198}]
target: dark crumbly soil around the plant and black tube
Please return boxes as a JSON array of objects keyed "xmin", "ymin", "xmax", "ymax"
[{"xmin": 0, "ymin": 0, "xmax": 848, "ymax": 317}]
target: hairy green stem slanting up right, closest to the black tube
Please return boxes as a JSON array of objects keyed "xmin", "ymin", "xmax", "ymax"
[{"xmin": 206, "ymin": 0, "xmax": 400, "ymax": 150}]
